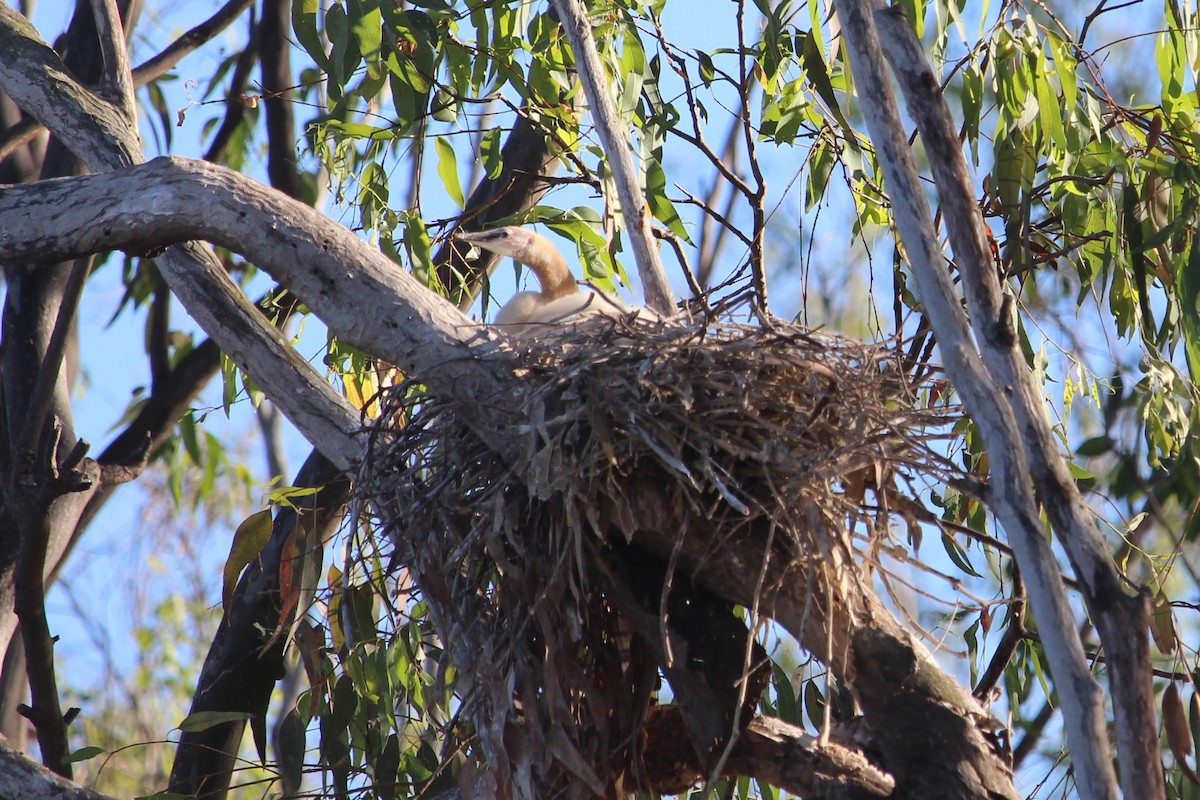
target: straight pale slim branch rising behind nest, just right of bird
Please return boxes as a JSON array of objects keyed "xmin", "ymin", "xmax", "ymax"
[{"xmin": 551, "ymin": 0, "xmax": 674, "ymax": 314}]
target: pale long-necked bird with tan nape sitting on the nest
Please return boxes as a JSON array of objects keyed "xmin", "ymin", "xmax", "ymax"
[{"xmin": 455, "ymin": 225, "xmax": 659, "ymax": 336}]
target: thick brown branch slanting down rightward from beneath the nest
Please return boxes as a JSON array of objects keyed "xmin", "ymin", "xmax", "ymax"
[{"xmin": 631, "ymin": 501, "xmax": 1019, "ymax": 800}]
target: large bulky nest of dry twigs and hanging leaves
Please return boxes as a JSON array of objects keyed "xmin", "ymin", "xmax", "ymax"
[{"xmin": 359, "ymin": 323, "xmax": 958, "ymax": 798}]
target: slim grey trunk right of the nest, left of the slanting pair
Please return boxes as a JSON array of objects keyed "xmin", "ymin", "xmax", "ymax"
[{"xmin": 836, "ymin": 0, "xmax": 1118, "ymax": 798}]
